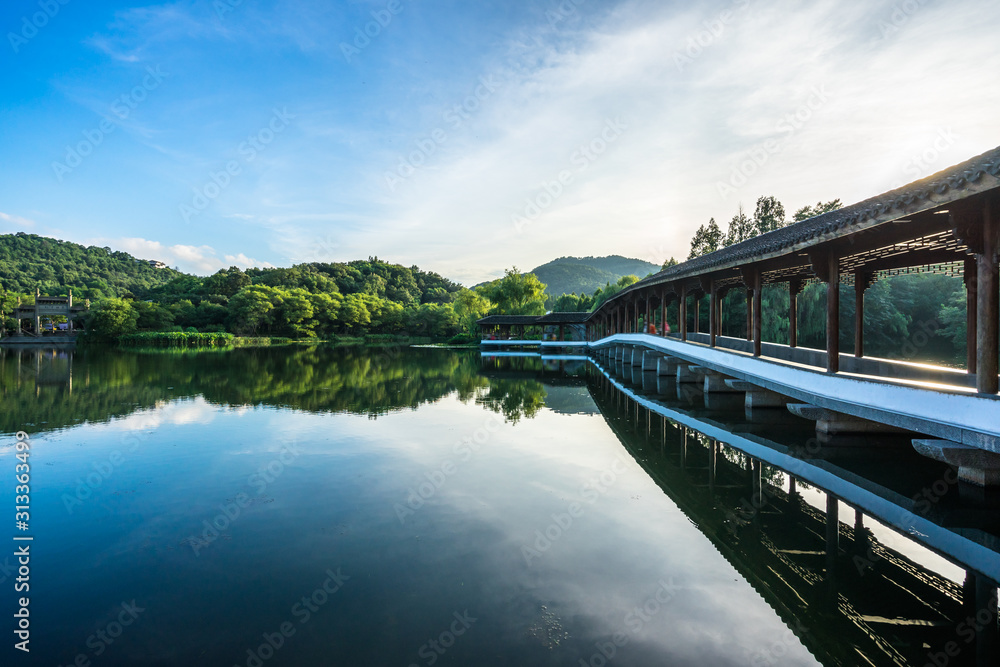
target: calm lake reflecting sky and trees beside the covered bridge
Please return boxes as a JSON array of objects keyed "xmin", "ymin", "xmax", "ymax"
[{"xmin": 0, "ymin": 346, "xmax": 1000, "ymax": 667}]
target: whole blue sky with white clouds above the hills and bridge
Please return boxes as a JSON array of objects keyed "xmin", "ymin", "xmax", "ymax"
[{"xmin": 0, "ymin": 0, "xmax": 1000, "ymax": 284}]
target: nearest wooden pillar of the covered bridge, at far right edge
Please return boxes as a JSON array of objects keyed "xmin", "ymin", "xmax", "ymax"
[{"xmin": 976, "ymin": 201, "xmax": 1000, "ymax": 394}]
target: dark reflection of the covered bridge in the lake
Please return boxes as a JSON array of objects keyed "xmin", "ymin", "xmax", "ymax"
[{"xmin": 494, "ymin": 352, "xmax": 1000, "ymax": 665}]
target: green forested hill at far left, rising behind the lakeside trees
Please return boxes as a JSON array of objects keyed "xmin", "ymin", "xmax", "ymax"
[{"xmin": 0, "ymin": 232, "xmax": 184, "ymax": 299}]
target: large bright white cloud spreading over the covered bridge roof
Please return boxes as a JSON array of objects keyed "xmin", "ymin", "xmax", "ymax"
[{"xmin": 275, "ymin": 0, "xmax": 1000, "ymax": 282}]
